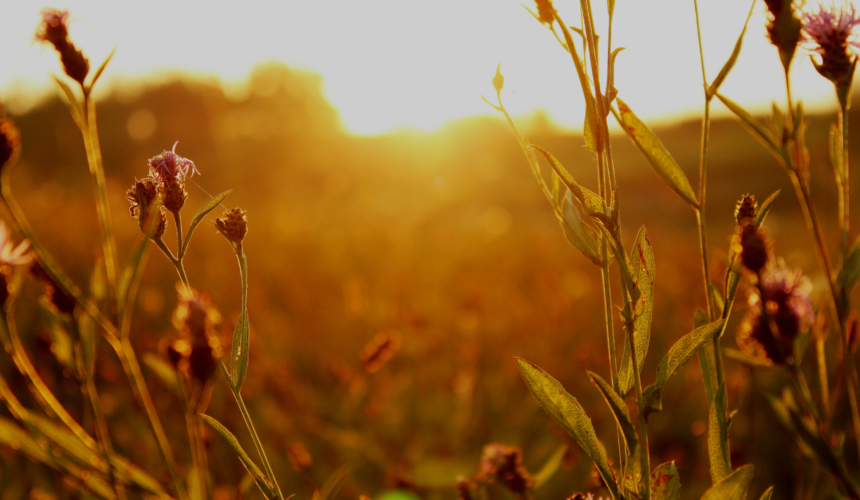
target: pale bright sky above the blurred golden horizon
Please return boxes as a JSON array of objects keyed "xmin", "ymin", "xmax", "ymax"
[{"xmin": 0, "ymin": 0, "xmax": 848, "ymax": 134}]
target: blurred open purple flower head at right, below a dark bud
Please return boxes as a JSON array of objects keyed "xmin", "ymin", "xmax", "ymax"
[{"xmin": 738, "ymin": 259, "xmax": 815, "ymax": 365}]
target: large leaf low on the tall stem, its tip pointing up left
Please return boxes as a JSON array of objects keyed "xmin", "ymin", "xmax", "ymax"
[{"xmin": 516, "ymin": 358, "xmax": 618, "ymax": 498}]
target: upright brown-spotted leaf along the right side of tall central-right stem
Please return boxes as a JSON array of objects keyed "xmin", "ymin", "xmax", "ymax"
[{"xmin": 618, "ymin": 227, "xmax": 657, "ymax": 397}]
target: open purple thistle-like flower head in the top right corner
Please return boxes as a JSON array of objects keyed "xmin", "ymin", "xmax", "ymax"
[{"xmin": 803, "ymin": 2, "xmax": 860, "ymax": 94}]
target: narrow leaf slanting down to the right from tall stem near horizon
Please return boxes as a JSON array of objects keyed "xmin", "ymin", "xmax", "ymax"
[{"xmin": 613, "ymin": 98, "xmax": 699, "ymax": 207}]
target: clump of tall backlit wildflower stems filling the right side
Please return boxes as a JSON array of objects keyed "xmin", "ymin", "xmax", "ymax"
[{"xmin": 484, "ymin": 0, "xmax": 860, "ymax": 500}]
